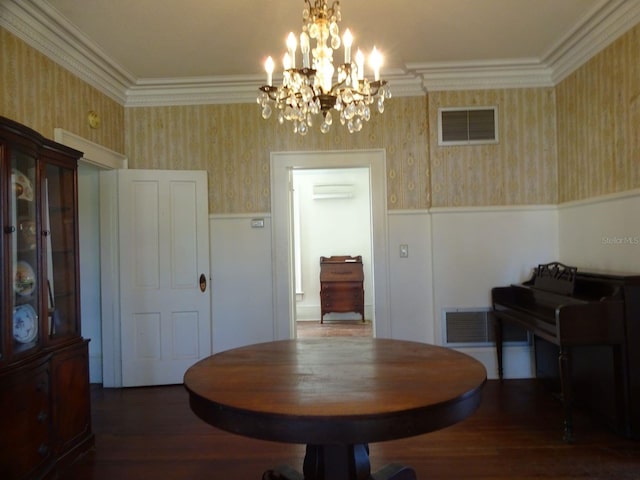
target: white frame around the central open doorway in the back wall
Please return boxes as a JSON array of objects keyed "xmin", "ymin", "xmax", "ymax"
[{"xmin": 271, "ymin": 149, "xmax": 391, "ymax": 340}]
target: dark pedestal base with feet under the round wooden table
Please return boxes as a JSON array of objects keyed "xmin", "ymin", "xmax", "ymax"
[{"xmin": 262, "ymin": 444, "xmax": 417, "ymax": 480}]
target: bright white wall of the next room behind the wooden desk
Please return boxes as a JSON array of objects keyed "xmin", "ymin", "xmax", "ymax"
[{"xmin": 293, "ymin": 168, "xmax": 373, "ymax": 321}]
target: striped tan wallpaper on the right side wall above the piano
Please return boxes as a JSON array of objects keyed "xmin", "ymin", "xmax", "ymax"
[{"xmin": 556, "ymin": 25, "xmax": 640, "ymax": 202}]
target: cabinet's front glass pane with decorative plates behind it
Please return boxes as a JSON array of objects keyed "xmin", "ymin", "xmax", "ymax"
[{"xmin": 10, "ymin": 151, "xmax": 40, "ymax": 353}]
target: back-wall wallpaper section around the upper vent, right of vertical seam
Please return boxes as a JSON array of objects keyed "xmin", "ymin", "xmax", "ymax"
[{"xmin": 429, "ymin": 88, "xmax": 557, "ymax": 207}]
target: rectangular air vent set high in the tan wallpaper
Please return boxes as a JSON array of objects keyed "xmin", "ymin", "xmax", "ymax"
[{"xmin": 438, "ymin": 107, "xmax": 498, "ymax": 146}]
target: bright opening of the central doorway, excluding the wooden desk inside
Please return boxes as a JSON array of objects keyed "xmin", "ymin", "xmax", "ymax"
[{"xmin": 292, "ymin": 167, "xmax": 374, "ymax": 337}]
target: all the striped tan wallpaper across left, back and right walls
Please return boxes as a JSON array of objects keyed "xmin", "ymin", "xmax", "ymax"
[{"xmin": 0, "ymin": 26, "xmax": 640, "ymax": 213}]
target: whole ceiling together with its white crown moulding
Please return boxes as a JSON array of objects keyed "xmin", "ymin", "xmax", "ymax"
[{"xmin": 0, "ymin": 0, "xmax": 640, "ymax": 104}]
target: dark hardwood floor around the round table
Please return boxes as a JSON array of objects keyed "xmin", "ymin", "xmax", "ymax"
[{"xmin": 64, "ymin": 380, "xmax": 640, "ymax": 480}]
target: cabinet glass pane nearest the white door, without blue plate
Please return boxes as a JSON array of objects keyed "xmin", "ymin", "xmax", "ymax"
[{"xmin": 42, "ymin": 164, "xmax": 79, "ymax": 339}]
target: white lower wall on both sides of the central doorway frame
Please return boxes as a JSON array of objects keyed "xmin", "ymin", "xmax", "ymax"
[{"xmin": 210, "ymin": 211, "xmax": 434, "ymax": 352}]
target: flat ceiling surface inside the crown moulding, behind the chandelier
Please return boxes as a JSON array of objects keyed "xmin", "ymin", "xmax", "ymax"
[{"xmin": 43, "ymin": 0, "xmax": 599, "ymax": 78}]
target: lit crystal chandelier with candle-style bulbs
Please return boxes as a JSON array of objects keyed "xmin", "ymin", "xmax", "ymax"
[{"xmin": 258, "ymin": 0, "xmax": 391, "ymax": 135}]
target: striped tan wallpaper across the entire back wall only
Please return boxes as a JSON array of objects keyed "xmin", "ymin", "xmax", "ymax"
[{"xmin": 125, "ymin": 89, "xmax": 557, "ymax": 213}]
